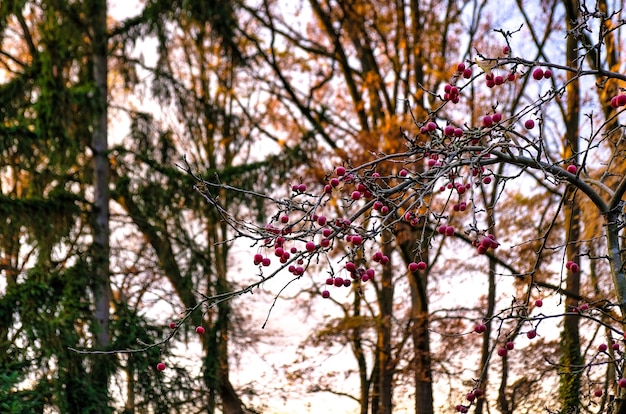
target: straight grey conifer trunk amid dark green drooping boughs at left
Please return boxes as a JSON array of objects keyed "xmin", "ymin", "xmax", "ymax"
[{"xmin": 88, "ymin": 0, "xmax": 111, "ymax": 413}]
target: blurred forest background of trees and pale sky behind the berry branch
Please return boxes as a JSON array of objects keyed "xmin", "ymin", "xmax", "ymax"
[{"xmin": 0, "ymin": 0, "xmax": 625, "ymax": 414}]
